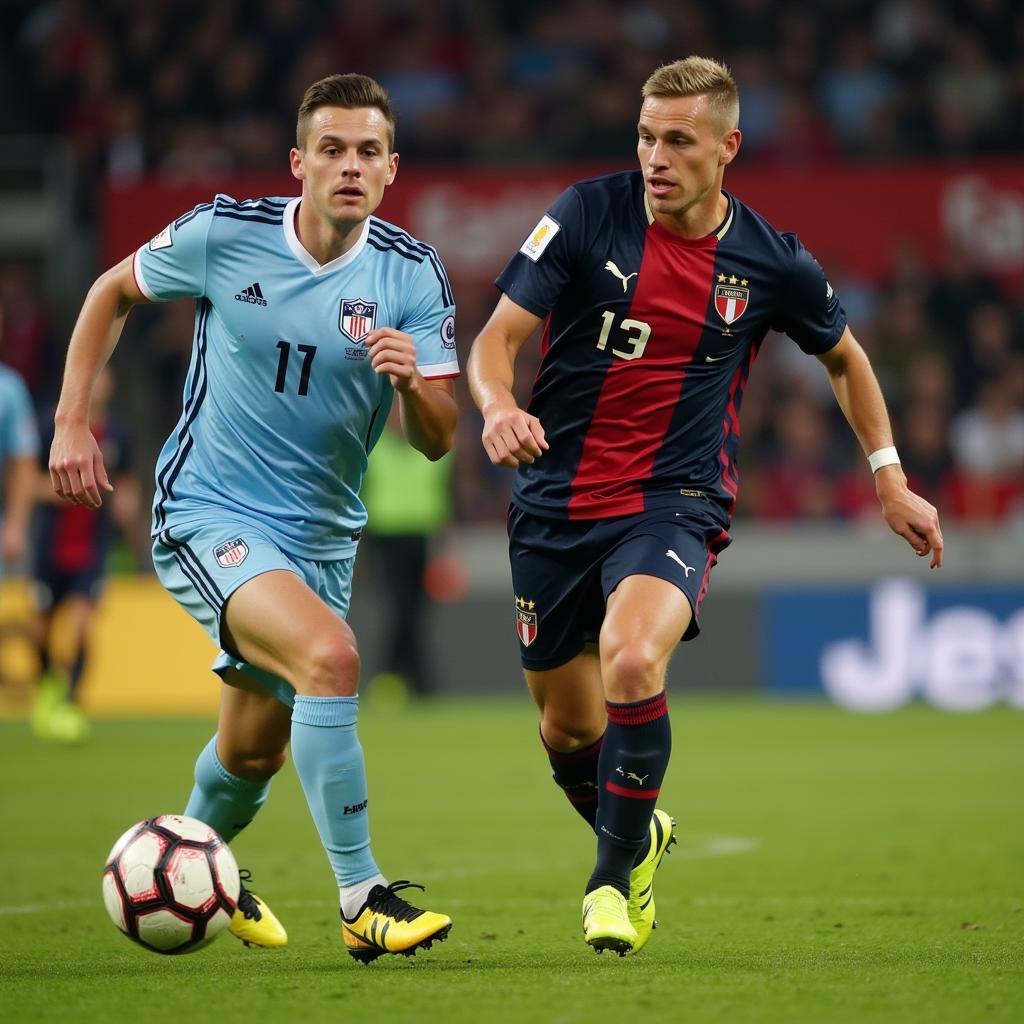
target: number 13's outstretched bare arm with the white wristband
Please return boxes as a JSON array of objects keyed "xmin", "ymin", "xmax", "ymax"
[{"xmin": 818, "ymin": 328, "xmax": 942, "ymax": 569}]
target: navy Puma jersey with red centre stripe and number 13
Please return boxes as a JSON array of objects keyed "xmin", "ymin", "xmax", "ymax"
[{"xmin": 496, "ymin": 171, "xmax": 846, "ymax": 519}]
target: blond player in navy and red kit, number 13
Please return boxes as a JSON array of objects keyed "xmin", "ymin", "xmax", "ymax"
[{"xmin": 469, "ymin": 57, "xmax": 942, "ymax": 953}]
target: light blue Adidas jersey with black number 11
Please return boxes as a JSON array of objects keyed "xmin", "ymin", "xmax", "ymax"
[{"xmin": 133, "ymin": 196, "xmax": 459, "ymax": 560}]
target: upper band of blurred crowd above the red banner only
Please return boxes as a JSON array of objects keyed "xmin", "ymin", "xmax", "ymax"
[{"xmin": 6, "ymin": 0, "xmax": 1024, "ymax": 188}]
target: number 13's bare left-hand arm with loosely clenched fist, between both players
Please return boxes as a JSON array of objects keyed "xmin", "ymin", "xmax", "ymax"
[{"xmin": 467, "ymin": 295, "xmax": 548, "ymax": 468}]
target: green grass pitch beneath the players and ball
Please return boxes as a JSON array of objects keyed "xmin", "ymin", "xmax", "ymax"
[{"xmin": 0, "ymin": 695, "xmax": 1024, "ymax": 1024}]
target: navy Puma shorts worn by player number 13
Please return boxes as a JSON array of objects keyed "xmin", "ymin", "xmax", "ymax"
[{"xmin": 508, "ymin": 498, "xmax": 730, "ymax": 670}]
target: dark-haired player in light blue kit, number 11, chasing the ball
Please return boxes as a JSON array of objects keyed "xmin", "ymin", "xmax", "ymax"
[{"xmin": 50, "ymin": 75, "xmax": 459, "ymax": 963}]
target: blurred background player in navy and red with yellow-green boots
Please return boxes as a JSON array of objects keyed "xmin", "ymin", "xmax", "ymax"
[{"xmin": 32, "ymin": 367, "xmax": 139, "ymax": 743}]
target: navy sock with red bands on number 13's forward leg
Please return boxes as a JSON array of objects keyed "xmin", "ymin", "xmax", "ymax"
[{"xmin": 587, "ymin": 690, "xmax": 672, "ymax": 897}]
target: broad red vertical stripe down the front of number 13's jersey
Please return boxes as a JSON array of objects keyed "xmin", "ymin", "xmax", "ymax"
[{"xmin": 568, "ymin": 233, "xmax": 718, "ymax": 519}]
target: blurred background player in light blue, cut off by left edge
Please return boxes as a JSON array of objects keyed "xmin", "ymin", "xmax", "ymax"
[{"xmin": 0, "ymin": 365, "xmax": 39, "ymax": 580}]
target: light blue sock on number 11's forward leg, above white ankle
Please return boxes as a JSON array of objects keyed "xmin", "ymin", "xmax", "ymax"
[{"xmin": 292, "ymin": 696, "xmax": 379, "ymax": 887}]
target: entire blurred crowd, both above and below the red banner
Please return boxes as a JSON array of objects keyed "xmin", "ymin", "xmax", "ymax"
[{"xmin": 0, "ymin": 0, "xmax": 1024, "ymax": 526}]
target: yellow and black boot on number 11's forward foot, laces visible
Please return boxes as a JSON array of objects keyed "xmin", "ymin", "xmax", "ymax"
[{"xmin": 341, "ymin": 880, "xmax": 452, "ymax": 964}]
